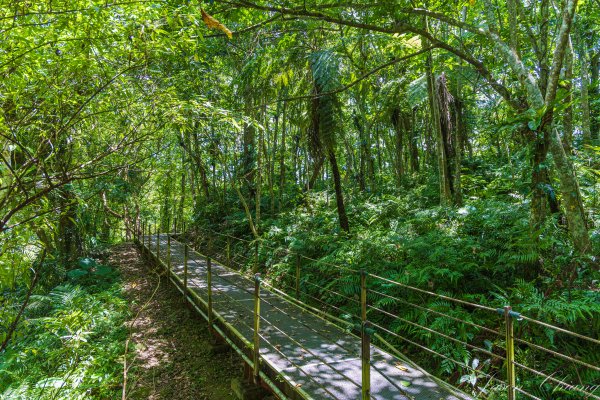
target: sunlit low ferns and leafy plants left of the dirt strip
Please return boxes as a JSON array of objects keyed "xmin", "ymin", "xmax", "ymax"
[{"xmin": 0, "ymin": 259, "xmax": 128, "ymax": 400}]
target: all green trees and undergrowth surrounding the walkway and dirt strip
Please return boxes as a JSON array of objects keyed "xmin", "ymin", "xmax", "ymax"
[{"xmin": 0, "ymin": 0, "xmax": 600, "ymax": 399}]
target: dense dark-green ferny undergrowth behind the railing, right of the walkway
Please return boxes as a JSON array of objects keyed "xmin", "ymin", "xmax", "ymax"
[{"xmin": 195, "ymin": 179, "xmax": 600, "ymax": 399}]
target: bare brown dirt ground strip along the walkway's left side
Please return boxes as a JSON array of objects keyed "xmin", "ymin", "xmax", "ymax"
[{"xmin": 110, "ymin": 244, "xmax": 240, "ymax": 400}]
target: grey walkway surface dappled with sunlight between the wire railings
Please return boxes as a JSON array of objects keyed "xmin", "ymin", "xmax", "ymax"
[{"xmin": 139, "ymin": 235, "xmax": 470, "ymax": 400}]
